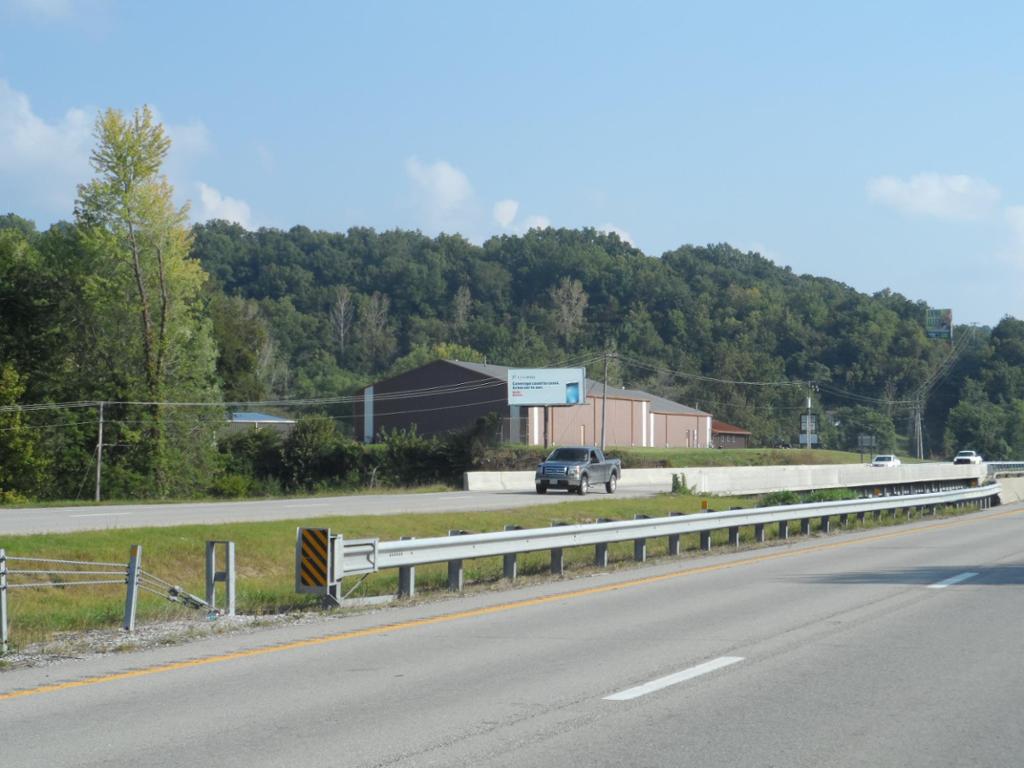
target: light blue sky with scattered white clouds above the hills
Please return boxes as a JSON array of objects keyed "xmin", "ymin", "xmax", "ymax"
[{"xmin": 0, "ymin": 0, "xmax": 1024, "ymax": 325}]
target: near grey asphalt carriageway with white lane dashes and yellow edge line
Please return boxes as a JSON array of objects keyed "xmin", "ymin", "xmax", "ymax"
[{"xmin": 0, "ymin": 505, "xmax": 1024, "ymax": 768}]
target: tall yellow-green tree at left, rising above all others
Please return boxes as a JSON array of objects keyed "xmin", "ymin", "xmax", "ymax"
[{"xmin": 75, "ymin": 106, "xmax": 218, "ymax": 496}]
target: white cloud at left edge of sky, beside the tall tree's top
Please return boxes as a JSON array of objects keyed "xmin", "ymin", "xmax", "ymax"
[{"xmin": 0, "ymin": 80, "xmax": 92, "ymax": 215}]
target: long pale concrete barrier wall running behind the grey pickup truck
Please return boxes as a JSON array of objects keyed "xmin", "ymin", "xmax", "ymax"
[{"xmin": 463, "ymin": 462, "xmax": 985, "ymax": 496}]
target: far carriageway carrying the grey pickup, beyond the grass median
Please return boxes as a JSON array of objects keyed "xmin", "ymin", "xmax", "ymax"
[{"xmin": 0, "ymin": 485, "xmax": 669, "ymax": 535}]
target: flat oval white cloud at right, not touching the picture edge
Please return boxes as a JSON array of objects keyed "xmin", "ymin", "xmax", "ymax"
[{"xmin": 867, "ymin": 173, "xmax": 999, "ymax": 219}]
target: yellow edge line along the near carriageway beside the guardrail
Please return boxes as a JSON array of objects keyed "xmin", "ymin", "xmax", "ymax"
[{"xmin": 0, "ymin": 509, "xmax": 1022, "ymax": 701}]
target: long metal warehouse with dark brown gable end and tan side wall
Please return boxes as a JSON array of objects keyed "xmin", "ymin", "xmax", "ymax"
[{"xmin": 355, "ymin": 360, "xmax": 712, "ymax": 447}]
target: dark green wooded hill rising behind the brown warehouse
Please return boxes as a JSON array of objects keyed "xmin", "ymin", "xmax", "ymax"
[{"xmin": 193, "ymin": 222, "xmax": 1024, "ymax": 455}]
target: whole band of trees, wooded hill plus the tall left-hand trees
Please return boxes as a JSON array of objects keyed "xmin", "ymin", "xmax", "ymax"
[{"xmin": 0, "ymin": 111, "xmax": 1024, "ymax": 501}]
